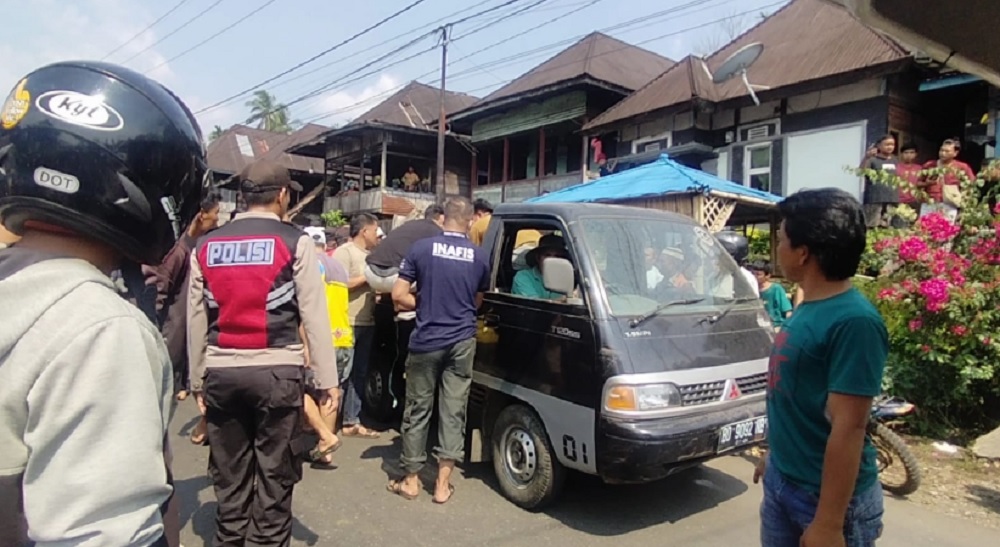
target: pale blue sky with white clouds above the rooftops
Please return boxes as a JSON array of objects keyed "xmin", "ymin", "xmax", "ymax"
[{"xmin": 0, "ymin": 0, "xmax": 783, "ymax": 134}]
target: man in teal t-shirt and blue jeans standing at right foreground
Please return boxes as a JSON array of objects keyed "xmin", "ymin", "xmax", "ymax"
[{"xmin": 754, "ymin": 188, "xmax": 889, "ymax": 547}]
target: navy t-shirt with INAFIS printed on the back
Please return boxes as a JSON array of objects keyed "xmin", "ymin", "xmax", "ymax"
[{"xmin": 399, "ymin": 232, "xmax": 490, "ymax": 353}]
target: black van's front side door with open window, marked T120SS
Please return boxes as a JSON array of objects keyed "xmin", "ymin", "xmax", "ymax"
[{"xmin": 475, "ymin": 217, "xmax": 603, "ymax": 473}]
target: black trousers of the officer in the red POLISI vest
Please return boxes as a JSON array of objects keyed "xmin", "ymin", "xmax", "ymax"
[{"xmin": 204, "ymin": 365, "xmax": 304, "ymax": 547}]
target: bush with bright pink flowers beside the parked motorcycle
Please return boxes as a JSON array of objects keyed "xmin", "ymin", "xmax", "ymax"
[{"xmin": 861, "ymin": 192, "xmax": 1000, "ymax": 435}]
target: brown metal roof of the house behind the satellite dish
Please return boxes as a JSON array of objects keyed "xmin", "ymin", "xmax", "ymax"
[{"xmin": 585, "ymin": 0, "xmax": 909, "ymax": 129}]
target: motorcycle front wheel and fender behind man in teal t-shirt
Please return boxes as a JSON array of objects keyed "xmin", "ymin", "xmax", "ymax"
[{"xmin": 868, "ymin": 397, "xmax": 920, "ymax": 496}]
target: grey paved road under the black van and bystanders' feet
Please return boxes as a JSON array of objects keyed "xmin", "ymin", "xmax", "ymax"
[{"xmin": 171, "ymin": 400, "xmax": 997, "ymax": 547}]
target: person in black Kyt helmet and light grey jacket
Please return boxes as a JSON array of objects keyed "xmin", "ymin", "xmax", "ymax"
[{"xmin": 0, "ymin": 62, "xmax": 206, "ymax": 546}]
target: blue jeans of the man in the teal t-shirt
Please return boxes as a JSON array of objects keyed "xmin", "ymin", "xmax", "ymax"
[{"xmin": 760, "ymin": 462, "xmax": 883, "ymax": 547}]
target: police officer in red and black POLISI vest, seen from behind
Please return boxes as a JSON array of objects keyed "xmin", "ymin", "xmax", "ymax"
[{"xmin": 188, "ymin": 161, "xmax": 338, "ymax": 546}]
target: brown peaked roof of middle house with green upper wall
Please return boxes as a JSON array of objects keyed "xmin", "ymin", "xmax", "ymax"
[{"xmin": 466, "ymin": 32, "xmax": 674, "ymax": 109}]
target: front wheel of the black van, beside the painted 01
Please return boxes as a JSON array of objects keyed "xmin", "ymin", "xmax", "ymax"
[{"xmin": 490, "ymin": 404, "xmax": 566, "ymax": 511}]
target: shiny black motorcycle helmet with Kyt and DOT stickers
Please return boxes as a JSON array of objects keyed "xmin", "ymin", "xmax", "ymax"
[{"xmin": 0, "ymin": 62, "xmax": 207, "ymax": 265}]
